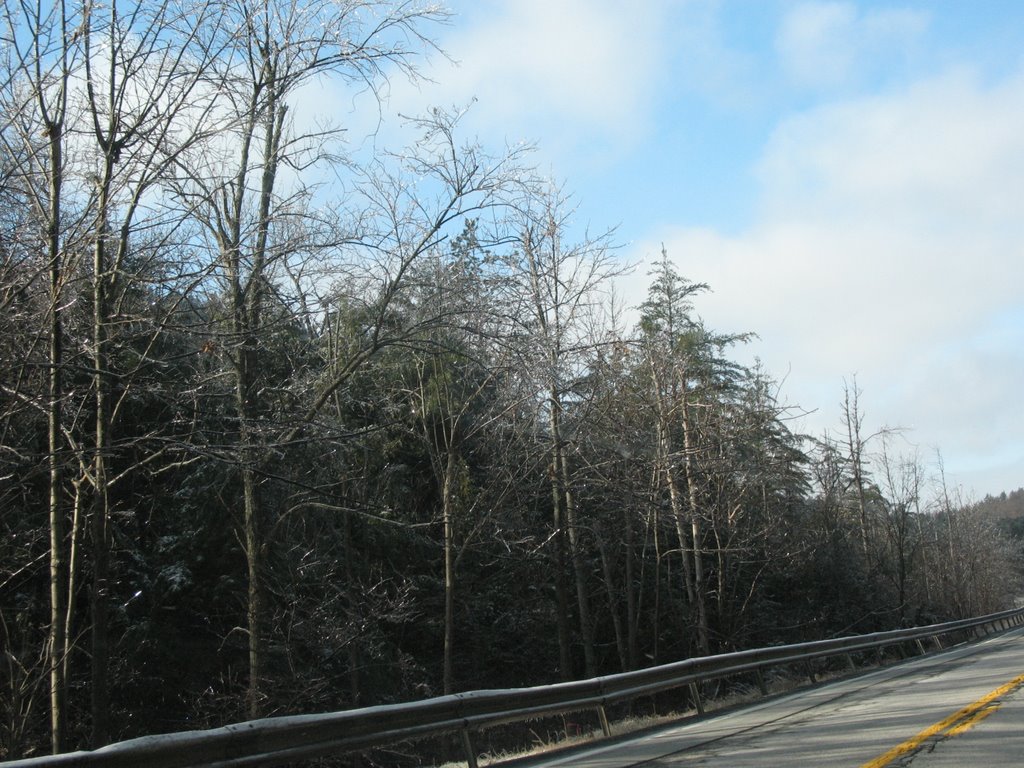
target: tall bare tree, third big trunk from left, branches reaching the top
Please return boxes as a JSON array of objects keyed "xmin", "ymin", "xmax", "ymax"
[{"xmin": 166, "ymin": 0, "xmax": 452, "ymax": 717}]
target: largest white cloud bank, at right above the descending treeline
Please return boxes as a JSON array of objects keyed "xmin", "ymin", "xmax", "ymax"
[{"xmin": 618, "ymin": 72, "xmax": 1024, "ymax": 499}]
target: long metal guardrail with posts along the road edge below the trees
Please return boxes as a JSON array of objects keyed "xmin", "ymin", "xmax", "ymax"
[{"xmin": 8, "ymin": 608, "xmax": 1024, "ymax": 768}]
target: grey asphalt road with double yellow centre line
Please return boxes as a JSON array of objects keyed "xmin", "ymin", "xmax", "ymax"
[{"xmin": 531, "ymin": 628, "xmax": 1024, "ymax": 768}]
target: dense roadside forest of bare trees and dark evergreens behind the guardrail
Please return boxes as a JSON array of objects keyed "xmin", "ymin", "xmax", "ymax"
[{"xmin": 0, "ymin": 0, "xmax": 1024, "ymax": 759}]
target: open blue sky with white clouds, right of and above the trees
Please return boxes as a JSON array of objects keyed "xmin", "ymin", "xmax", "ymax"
[{"xmin": 335, "ymin": 0, "xmax": 1024, "ymax": 499}]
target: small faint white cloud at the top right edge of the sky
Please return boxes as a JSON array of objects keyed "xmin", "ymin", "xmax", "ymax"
[{"xmin": 775, "ymin": 2, "xmax": 928, "ymax": 88}]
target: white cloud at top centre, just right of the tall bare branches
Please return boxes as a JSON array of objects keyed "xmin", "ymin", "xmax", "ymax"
[{"xmin": 344, "ymin": 0, "xmax": 667, "ymax": 155}]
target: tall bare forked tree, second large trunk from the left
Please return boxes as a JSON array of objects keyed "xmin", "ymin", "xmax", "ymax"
[{"xmin": 73, "ymin": 0, "xmax": 230, "ymax": 746}]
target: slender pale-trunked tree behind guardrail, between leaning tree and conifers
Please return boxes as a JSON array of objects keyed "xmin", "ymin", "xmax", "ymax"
[{"xmin": 399, "ymin": 225, "xmax": 544, "ymax": 693}]
